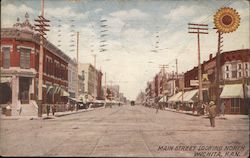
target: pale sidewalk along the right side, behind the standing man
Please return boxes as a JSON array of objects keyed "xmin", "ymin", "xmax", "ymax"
[{"xmin": 162, "ymin": 108, "xmax": 249, "ymax": 120}]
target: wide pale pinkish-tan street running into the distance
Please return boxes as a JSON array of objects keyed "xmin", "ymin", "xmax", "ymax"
[{"xmin": 0, "ymin": 105, "xmax": 249, "ymax": 157}]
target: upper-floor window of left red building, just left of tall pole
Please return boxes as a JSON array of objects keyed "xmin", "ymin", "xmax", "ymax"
[{"xmin": 20, "ymin": 48, "xmax": 31, "ymax": 69}]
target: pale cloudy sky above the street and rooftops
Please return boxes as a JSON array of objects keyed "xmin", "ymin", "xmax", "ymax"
[{"xmin": 1, "ymin": 0, "xmax": 249, "ymax": 99}]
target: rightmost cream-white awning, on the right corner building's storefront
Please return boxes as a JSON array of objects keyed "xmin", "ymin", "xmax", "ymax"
[{"xmin": 220, "ymin": 84, "xmax": 244, "ymax": 98}]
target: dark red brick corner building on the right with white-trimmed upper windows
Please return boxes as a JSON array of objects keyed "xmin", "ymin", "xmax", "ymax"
[{"xmin": 184, "ymin": 49, "xmax": 250, "ymax": 114}]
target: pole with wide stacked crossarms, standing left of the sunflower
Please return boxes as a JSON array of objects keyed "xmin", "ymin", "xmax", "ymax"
[{"xmin": 188, "ymin": 23, "xmax": 208, "ymax": 103}]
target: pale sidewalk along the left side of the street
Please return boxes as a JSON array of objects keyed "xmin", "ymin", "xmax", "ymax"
[{"xmin": 0, "ymin": 107, "xmax": 104, "ymax": 120}]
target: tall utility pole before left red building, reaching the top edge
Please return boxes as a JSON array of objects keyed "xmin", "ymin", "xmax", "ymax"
[{"xmin": 35, "ymin": 0, "xmax": 50, "ymax": 117}]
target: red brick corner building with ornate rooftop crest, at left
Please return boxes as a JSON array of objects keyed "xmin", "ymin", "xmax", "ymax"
[{"xmin": 0, "ymin": 14, "xmax": 70, "ymax": 115}]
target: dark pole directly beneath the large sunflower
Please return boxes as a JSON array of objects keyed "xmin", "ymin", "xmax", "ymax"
[{"xmin": 215, "ymin": 30, "xmax": 223, "ymax": 110}]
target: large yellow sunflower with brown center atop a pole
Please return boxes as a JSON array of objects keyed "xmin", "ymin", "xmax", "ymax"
[{"xmin": 214, "ymin": 7, "xmax": 240, "ymax": 33}]
